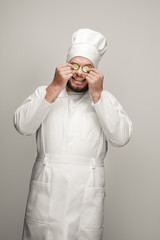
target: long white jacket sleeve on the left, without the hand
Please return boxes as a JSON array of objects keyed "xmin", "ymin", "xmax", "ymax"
[{"xmin": 13, "ymin": 86, "xmax": 52, "ymax": 135}]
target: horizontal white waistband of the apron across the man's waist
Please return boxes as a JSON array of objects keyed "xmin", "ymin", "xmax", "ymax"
[{"xmin": 36, "ymin": 153, "xmax": 104, "ymax": 167}]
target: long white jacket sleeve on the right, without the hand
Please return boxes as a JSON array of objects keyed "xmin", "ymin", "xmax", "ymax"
[{"xmin": 92, "ymin": 90, "xmax": 133, "ymax": 147}]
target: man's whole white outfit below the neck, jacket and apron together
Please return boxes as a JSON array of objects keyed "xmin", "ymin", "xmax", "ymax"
[{"xmin": 14, "ymin": 86, "xmax": 132, "ymax": 240}]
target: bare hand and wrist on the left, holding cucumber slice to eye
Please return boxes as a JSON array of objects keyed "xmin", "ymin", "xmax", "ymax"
[{"xmin": 45, "ymin": 63, "xmax": 74, "ymax": 103}]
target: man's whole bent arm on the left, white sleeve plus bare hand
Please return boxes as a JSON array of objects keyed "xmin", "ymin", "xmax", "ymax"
[{"xmin": 13, "ymin": 63, "xmax": 73, "ymax": 135}]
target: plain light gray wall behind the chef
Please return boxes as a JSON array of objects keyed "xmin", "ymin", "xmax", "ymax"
[{"xmin": 0, "ymin": 0, "xmax": 160, "ymax": 240}]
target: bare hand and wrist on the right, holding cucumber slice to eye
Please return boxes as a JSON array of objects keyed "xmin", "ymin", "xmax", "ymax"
[{"xmin": 86, "ymin": 68, "xmax": 104, "ymax": 103}]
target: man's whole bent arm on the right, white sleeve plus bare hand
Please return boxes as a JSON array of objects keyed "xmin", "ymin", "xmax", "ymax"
[{"xmin": 86, "ymin": 68, "xmax": 133, "ymax": 147}]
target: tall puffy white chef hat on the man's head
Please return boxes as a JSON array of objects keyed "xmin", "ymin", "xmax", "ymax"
[{"xmin": 66, "ymin": 28, "xmax": 107, "ymax": 68}]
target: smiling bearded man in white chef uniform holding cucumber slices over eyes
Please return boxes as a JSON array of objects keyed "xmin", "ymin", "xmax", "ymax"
[{"xmin": 13, "ymin": 28, "xmax": 133, "ymax": 240}]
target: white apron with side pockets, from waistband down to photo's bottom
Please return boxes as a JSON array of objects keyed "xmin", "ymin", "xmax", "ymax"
[{"xmin": 23, "ymin": 154, "xmax": 105, "ymax": 240}]
